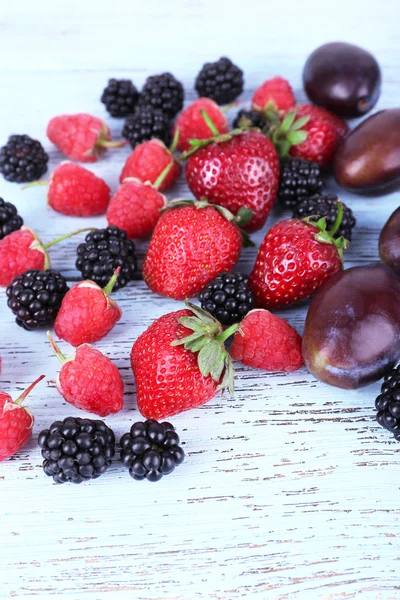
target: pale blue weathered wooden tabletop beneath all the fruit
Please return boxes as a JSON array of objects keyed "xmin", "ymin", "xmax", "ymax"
[{"xmin": 0, "ymin": 0, "xmax": 400, "ymax": 600}]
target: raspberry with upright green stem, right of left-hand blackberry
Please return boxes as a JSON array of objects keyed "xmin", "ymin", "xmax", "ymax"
[{"xmin": 54, "ymin": 267, "xmax": 122, "ymax": 346}]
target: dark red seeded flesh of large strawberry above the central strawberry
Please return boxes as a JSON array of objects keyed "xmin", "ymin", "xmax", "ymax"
[{"xmin": 186, "ymin": 131, "xmax": 279, "ymax": 231}]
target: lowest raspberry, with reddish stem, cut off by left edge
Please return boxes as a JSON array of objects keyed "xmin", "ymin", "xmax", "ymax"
[{"xmin": 0, "ymin": 375, "xmax": 45, "ymax": 462}]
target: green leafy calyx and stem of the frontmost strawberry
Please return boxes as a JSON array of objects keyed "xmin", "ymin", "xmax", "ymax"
[{"xmin": 171, "ymin": 300, "xmax": 239, "ymax": 396}]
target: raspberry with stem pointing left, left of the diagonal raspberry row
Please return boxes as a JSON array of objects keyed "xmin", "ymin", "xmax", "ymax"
[{"xmin": 25, "ymin": 161, "xmax": 110, "ymax": 217}]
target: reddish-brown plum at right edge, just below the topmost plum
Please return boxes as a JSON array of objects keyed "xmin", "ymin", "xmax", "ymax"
[{"xmin": 334, "ymin": 108, "xmax": 400, "ymax": 194}]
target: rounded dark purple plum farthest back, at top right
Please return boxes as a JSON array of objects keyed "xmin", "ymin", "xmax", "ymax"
[{"xmin": 303, "ymin": 42, "xmax": 381, "ymax": 117}]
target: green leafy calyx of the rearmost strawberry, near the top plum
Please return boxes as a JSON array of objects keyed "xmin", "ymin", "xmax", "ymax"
[{"xmin": 264, "ymin": 105, "xmax": 310, "ymax": 158}]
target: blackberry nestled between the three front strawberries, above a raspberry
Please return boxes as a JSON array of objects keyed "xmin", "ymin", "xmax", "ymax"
[{"xmin": 199, "ymin": 273, "xmax": 254, "ymax": 325}]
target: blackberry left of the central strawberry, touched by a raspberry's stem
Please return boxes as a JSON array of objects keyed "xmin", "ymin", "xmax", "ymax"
[{"xmin": 76, "ymin": 226, "xmax": 137, "ymax": 291}]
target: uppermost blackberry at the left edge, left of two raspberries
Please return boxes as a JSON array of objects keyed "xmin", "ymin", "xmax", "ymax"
[{"xmin": 0, "ymin": 135, "xmax": 49, "ymax": 183}]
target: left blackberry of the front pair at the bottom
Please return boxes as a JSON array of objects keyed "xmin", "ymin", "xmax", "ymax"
[{"xmin": 38, "ymin": 417, "xmax": 115, "ymax": 483}]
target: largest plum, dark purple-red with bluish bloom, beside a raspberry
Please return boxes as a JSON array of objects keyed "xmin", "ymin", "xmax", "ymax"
[{"xmin": 302, "ymin": 263, "xmax": 400, "ymax": 389}]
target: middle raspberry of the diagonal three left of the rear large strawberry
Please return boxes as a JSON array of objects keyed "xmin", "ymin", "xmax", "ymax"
[{"xmin": 119, "ymin": 138, "xmax": 181, "ymax": 192}]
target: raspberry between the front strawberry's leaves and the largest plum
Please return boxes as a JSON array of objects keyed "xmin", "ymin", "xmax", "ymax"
[{"xmin": 230, "ymin": 309, "xmax": 304, "ymax": 373}]
